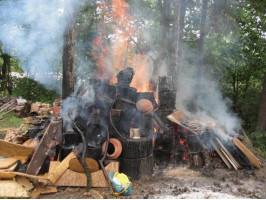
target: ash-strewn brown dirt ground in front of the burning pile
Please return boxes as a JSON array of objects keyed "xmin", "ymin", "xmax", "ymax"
[{"xmin": 39, "ymin": 160, "xmax": 266, "ymax": 199}]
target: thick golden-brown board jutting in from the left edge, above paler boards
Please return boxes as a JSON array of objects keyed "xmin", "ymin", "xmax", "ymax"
[{"xmin": 0, "ymin": 140, "xmax": 34, "ymax": 164}]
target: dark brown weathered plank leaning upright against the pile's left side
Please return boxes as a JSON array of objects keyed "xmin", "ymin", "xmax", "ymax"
[{"xmin": 26, "ymin": 120, "xmax": 62, "ymax": 175}]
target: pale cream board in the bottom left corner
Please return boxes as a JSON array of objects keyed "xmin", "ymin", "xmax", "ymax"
[{"xmin": 0, "ymin": 180, "xmax": 29, "ymax": 198}]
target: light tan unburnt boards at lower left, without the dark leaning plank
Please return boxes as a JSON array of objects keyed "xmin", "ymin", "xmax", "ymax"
[{"xmin": 0, "ymin": 140, "xmax": 119, "ymax": 198}]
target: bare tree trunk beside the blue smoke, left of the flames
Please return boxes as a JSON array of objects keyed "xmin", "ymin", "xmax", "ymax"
[{"xmin": 62, "ymin": 10, "xmax": 75, "ymax": 99}]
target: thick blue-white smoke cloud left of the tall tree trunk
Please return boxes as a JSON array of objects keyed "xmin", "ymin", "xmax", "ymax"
[{"xmin": 0, "ymin": 0, "xmax": 78, "ymax": 92}]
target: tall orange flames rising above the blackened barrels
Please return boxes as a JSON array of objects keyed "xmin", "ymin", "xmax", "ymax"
[{"xmin": 93, "ymin": 0, "xmax": 152, "ymax": 92}]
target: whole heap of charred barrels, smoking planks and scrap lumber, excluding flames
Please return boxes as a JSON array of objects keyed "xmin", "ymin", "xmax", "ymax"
[{"xmin": 0, "ymin": 68, "xmax": 260, "ymax": 198}]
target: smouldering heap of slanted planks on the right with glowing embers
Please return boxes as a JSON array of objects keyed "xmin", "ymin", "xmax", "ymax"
[{"xmin": 167, "ymin": 110, "xmax": 262, "ymax": 170}]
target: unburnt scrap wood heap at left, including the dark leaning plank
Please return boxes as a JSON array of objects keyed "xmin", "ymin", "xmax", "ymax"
[{"xmin": 0, "ymin": 117, "xmax": 119, "ymax": 198}]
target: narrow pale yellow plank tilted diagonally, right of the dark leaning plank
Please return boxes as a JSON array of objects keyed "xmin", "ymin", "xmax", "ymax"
[{"xmin": 48, "ymin": 152, "xmax": 76, "ymax": 183}]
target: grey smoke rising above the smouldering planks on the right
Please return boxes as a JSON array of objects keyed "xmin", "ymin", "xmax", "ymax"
[{"xmin": 176, "ymin": 45, "xmax": 240, "ymax": 135}]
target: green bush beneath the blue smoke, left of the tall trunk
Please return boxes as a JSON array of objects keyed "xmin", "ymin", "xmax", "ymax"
[{"xmin": 13, "ymin": 78, "xmax": 58, "ymax": 103}]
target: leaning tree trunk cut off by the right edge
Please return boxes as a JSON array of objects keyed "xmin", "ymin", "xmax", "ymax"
[{"xmin": 257, "ymin": 73, "xmax": 266, "ymax": 131}]
